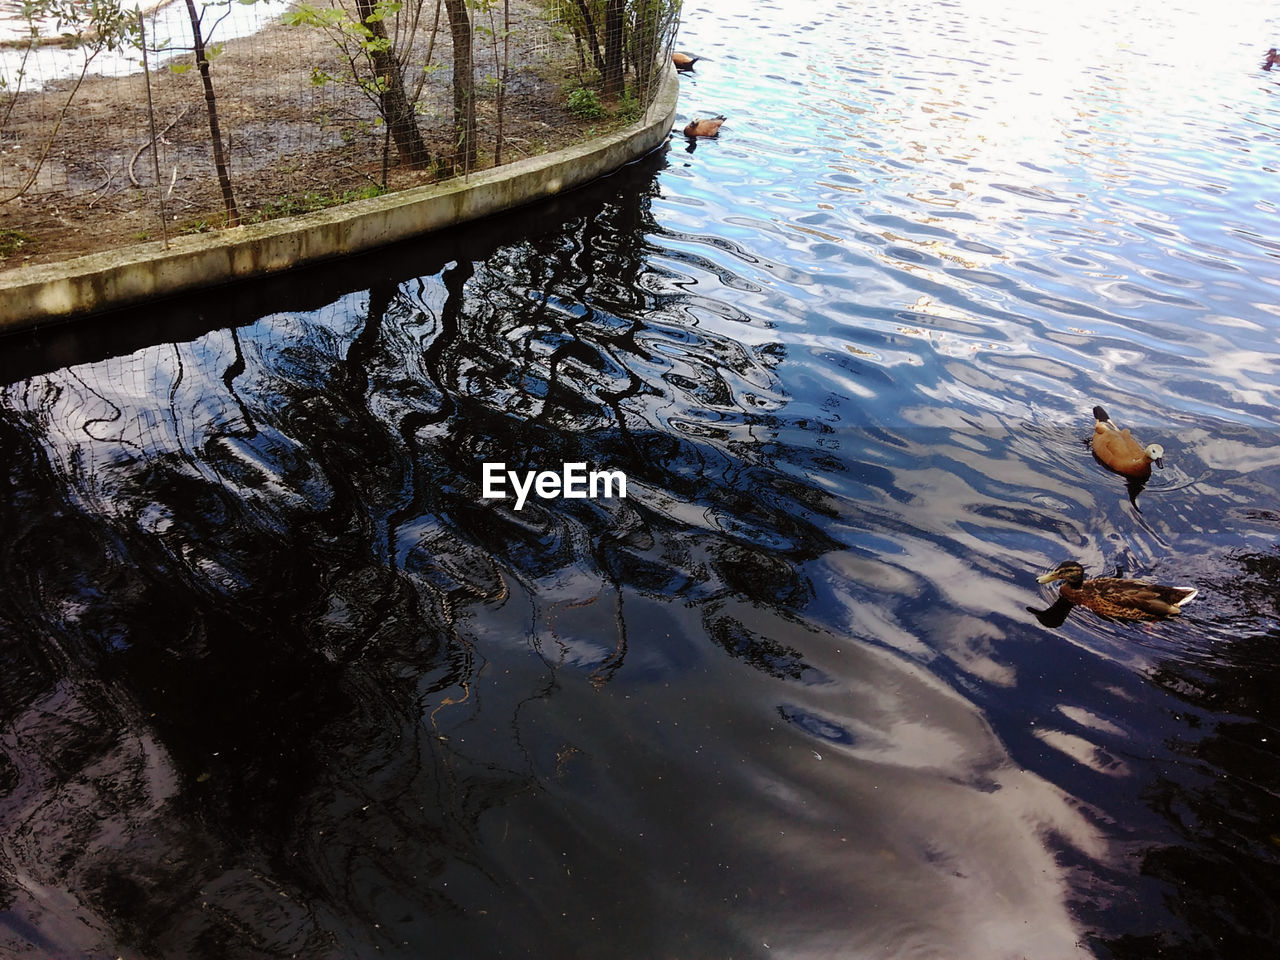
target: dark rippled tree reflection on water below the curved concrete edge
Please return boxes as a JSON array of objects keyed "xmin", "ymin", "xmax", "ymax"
[{"xmin": 0, "ymin": 156, "xmax": 849, "ymax": 957}]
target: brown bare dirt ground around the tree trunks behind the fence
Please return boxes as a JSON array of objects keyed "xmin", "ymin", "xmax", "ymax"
[{"xmin": 0, "ymin": 3, "xmax": 621, "ymax": 271}]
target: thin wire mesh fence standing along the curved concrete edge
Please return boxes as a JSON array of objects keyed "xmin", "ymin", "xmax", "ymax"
[{"xmin": 0, "ymin": 0, "xmax": 680, "ymax": 269}]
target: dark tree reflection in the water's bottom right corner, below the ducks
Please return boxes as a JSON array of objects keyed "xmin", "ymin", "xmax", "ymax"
[{"xmin": 1112, "ymin": 553, "xmax": 1280, "ymax": 959}]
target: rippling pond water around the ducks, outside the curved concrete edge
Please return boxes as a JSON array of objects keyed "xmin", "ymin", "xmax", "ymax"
[{"xmin": 0, "ymin": 0, "xmax": 1280, "ymax": 960}]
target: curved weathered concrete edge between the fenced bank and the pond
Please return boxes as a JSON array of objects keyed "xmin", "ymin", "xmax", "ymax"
[{"xmin": 0, "ymin": 64, "xmax": 680, "ymax": 330}]
